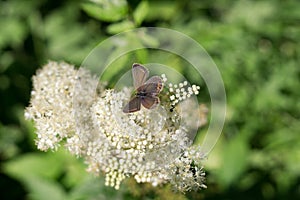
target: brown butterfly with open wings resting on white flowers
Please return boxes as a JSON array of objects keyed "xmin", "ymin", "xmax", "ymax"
[{"xmin": 123, "ymin": 63, "xmax": 163, "ymax": 113}]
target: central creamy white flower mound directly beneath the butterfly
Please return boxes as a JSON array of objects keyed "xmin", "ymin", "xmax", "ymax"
[{"xmin": 88, "ymin": 88, "xmax": 190, "ymax": 188}]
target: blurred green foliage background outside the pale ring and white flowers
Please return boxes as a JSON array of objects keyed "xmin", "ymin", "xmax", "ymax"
[{"xmin": 0, "ymin": 0, "xmax": 300, "ymax": 200}]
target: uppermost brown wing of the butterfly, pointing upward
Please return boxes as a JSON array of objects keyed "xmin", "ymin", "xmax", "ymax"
[{"xmin": 132, "ymin": 63, "xmax": 149, "ymax": 89}]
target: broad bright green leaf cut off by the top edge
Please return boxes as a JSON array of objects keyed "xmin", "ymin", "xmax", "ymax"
[{"xmin": 82, "ymin": 0, "xmax": 128, "ymax": 22}]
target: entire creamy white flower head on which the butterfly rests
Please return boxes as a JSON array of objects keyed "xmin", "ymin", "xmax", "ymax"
[{"xmin": 25, "ymin": 62, "xmax": 205, "ymax": 192}]
